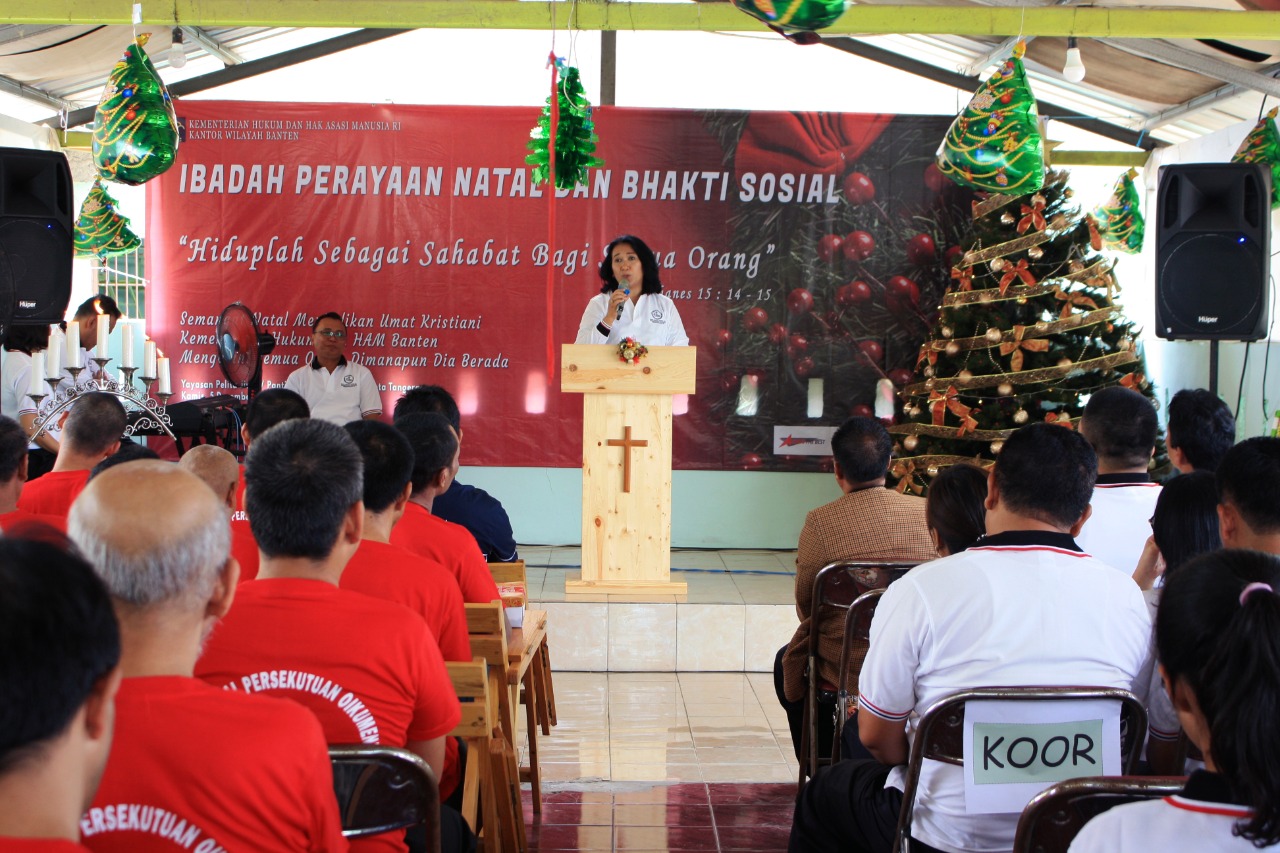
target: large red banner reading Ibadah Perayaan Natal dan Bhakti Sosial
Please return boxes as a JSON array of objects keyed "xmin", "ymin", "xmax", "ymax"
[{"xmin": 146, "ymin": 101, "xmax": 955, "ymax": 469}]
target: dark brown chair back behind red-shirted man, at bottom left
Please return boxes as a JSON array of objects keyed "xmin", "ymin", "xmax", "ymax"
[{"xmin": 329, "ymin": 745, "xmax": 440, "ymax": 853}]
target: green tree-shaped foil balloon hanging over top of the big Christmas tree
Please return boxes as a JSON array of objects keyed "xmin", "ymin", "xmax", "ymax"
[{"xmin": 937, "ymin": 42, "xmax": 1044, "ymax": 196}]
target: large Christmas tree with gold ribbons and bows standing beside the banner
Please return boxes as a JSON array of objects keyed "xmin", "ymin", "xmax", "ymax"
[{"xmin": 890, "ymin": 172, "xmax": 1164, "ymax": 493}]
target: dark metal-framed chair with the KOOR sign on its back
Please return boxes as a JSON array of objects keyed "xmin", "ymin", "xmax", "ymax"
[{"xmin": 893, "ymin": 686, "xmax": 1147, "ymax": 853}]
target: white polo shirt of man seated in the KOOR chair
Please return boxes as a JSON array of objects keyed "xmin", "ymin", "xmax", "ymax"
[{"xmin": 858, "ymin": 530, "xmax": 1151, "ymax": 853}]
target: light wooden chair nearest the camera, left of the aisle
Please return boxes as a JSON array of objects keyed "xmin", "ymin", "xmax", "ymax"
[{"xmin": 444, "ymin": 658, "xmax": 527, "ymax": 853}]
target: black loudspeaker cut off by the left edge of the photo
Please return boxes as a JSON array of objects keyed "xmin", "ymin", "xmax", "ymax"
[{"xmin": 0, "ymin": 149, "xmax": 73, "ymax": 325}]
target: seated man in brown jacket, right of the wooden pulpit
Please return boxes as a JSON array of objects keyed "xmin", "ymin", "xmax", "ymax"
[{"xmin": 773, "ymin": 418, "xmax": 937, "ymax": 757}]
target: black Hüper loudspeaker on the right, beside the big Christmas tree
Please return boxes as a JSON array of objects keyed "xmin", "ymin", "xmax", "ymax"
[{"xmin": 1156, "ymin": 163, "xmax": 1271, "ymax": 341}]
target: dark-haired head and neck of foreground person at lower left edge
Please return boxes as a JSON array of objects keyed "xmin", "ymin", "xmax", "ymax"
[{"xmin": 0, "ymin": 538, "xmax": 120, "ymax": 853}]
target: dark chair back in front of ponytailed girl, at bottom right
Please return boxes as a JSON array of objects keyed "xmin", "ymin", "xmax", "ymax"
[{"xmin": 1014, "ymin": 776, "xmax": 1187, "ymax": 853}]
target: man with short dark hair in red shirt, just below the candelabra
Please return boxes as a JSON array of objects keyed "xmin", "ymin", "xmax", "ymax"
[{"xmin": 18, "ymin": 391, "xmax": 127, "ymax": 517}]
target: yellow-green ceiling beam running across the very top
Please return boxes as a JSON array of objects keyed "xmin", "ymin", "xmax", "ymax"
[{"xmin": 0, "ymin": 0, "xmax": 1280, "ymax": 40}]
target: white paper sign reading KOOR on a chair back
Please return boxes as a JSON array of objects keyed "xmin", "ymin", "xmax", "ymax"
[{"xmin": 964, "ymin": 699, "xmax": 1121, "ymax": 815}]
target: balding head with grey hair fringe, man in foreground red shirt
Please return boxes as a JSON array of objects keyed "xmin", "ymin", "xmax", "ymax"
[{"xmin": 67, "ymin": 461, "xmax": 230, "ymax": 608}]
